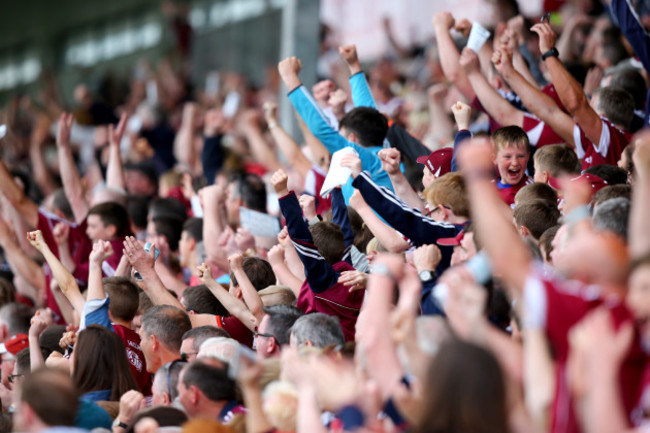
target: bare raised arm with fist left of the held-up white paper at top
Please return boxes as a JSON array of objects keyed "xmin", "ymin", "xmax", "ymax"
[{"xmin": 433, "ymin": 12, "xmax": 475, "ymax": 102}]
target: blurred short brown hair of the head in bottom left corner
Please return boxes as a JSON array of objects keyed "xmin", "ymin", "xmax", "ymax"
[{"xmin": 20, "ymin": 367, "xmax": 79, "ymax": 426}]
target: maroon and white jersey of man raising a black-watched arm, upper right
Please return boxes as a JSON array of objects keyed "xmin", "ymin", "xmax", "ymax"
[{"xmin": 573, "ymin": 117, "xmax": 632, "ymax": 170}]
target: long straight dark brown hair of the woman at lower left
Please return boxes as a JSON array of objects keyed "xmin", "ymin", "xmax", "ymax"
[{"xmin": 72, "ymin": 325, "xmax": 138, "ymax": 401}]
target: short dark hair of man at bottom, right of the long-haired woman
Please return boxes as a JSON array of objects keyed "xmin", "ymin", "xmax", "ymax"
[{"xmin": 182, "ymin": 358, "xmax": 237, "ymax": 401}]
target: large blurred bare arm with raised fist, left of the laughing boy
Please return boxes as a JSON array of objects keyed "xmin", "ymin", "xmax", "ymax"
[{"xmin": 458, "ymin": 139, "xmax": 532, "ymax": 294}]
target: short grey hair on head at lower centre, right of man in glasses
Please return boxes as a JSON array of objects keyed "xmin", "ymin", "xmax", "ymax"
[{"xmin": 291, "ymin": 313, "xmax": 345, "ymax": 348}]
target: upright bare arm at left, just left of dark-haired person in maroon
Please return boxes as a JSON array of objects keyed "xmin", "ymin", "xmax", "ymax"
[{"xmin": 56, "ymin": 114, "xmax": 89, "ymax": 223}]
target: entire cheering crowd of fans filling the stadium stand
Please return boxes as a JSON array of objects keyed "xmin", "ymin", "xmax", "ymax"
[{"xmin": 0, "ymin": 0, "xmax": 650, "ymax": 433}]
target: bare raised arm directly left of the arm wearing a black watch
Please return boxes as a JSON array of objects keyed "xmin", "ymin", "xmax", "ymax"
[{"xmin": 492, "ymin": 49, "xmax": 575, "ymax": 147}]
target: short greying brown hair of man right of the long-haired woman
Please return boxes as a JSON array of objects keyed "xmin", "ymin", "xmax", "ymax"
[{"xmin": 142, "ymin": 305, "xmax": 192, "ymax": 351}]
